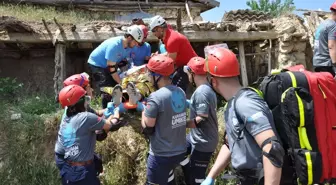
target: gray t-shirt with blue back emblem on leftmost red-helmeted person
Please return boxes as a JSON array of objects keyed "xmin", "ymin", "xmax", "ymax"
[{"xmin": 55, "ymin": 112, "xmax": 105, "ymax": 161}]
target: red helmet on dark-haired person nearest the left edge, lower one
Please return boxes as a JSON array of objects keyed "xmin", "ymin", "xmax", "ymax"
[{"xmin": 58, "ymin": 85, "xmax": 86, "ymax": 107}]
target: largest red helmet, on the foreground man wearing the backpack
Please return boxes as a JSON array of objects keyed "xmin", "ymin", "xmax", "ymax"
[{"xmin": 204, "ymin": 48, "xmax": 240, "ymax": 77}]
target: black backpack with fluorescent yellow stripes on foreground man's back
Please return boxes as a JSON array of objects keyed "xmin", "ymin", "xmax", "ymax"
[{"xmin": 230, "ymin": 71, "xmax": 322, "ymax": 184}]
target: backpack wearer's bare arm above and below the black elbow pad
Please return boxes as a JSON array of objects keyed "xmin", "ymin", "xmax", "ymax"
[{"xmin": 254, "ymin": 129, "xmax": 282, "ymax": 185}]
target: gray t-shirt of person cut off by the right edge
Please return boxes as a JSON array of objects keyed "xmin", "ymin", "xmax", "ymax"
[{"xmin": 313, "ymin": 19, "xmax": 336, "ymax": 67}]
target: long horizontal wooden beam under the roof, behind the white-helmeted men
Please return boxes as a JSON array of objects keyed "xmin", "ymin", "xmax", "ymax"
[{"xmin": 0, "ymin": 31, "xmax": 278, "ymax": 43}]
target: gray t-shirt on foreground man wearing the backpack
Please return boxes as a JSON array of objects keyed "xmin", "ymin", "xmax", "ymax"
[{"xmin": 224, "ymin": 90, "xmax": 277, "ymax": 170}]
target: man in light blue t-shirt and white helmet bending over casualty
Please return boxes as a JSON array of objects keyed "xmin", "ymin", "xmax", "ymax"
[{"xmin": 88, "ymin": 25, "xmax": 144, "ymax": 108}]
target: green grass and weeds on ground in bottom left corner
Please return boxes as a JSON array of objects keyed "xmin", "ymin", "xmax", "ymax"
[{"xmin": 0, "ymin": 98, "xmax": 60, "ymax": 185}]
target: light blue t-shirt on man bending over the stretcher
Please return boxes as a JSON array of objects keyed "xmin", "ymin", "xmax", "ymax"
[{"xmin": 88, "ymin": 36, "xmax": 132, "ymax": 68}]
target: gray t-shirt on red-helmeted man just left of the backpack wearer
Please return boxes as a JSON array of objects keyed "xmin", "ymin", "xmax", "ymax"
[{"xmin": 189, "ymin": 84, "xmax": 218, "ymax": 152}]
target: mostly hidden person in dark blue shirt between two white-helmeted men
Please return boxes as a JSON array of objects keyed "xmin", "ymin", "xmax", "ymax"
[{"xmin": 132, "ymin": 25, "xmax": 152, "ymax": 66}]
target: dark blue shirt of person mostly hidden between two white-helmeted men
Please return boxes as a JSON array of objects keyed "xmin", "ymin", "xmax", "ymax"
[{"xmin": 131, "ymin": 42, "xmax": 152, "ymax": 66}]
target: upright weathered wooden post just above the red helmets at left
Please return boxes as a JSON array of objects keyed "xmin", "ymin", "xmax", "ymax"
[{"xmin": 54, "ymin": 43, "xmax": 66, "ymax": 98}]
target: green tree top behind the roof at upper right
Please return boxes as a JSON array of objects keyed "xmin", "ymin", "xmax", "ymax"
[{"xmin": 246, "ymin": 0, "xmax": 295, "ymax": 17}]
